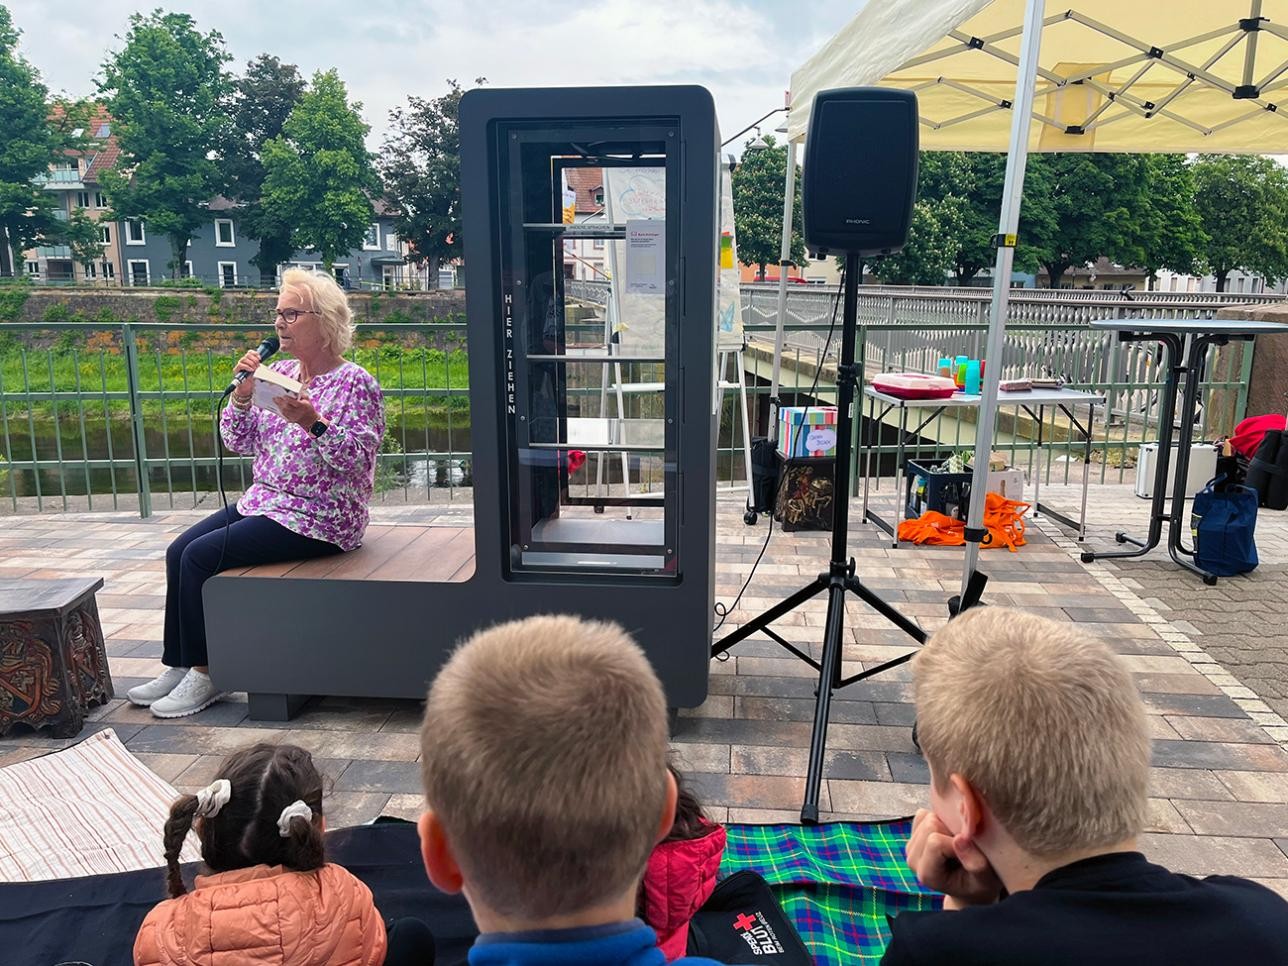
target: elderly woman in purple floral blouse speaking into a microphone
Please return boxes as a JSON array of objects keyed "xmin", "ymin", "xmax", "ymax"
[{"xmin": 129, "ymin": 269, "xmax": 385, "ymax": 717}]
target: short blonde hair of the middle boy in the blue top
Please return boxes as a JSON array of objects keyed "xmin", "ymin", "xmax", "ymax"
[{"xmin": 420, "ymin": 617, "xmax": 667, "ymax": 920}]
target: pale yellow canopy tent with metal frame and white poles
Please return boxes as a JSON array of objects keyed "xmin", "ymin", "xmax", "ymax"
[{"xmin": 775, "ymin": 0, "xmax": 1288, "ymax": 592}]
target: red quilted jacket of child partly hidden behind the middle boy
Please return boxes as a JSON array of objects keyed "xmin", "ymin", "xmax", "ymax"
[{"xmin": 640, "ymin": 822, "xmax": 725, "ymax": 962}]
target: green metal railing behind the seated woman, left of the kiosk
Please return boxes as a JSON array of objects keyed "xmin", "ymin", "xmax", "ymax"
[{"xmin": 0, "ymin": 322, "xmax": 471, "ymax": 516}]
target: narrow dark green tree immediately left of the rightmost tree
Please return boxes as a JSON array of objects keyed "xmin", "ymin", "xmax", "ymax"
[{"xmin": 1132, "ymin": 155, "xmax": 1207, "ymax": 287}]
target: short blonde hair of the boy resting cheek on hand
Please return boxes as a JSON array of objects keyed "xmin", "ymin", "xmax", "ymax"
[{"xmin": 912, "ymin": 607, "xmax": 1149, "ymax": 857}]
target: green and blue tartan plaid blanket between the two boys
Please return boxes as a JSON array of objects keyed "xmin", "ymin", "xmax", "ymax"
[{"xmin": 720, "ymin": 819, "xmax": 939, "ymax": 966}]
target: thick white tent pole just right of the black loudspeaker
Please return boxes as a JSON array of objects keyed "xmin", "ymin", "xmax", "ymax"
[{"xmin": 962, "ymin": 0, "xmax": 1046, "ymax": 600}]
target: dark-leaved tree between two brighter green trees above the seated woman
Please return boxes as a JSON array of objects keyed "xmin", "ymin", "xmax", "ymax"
[{"xmin": 224, "ymin": 54, "xmax": 305, "ymax": 283}]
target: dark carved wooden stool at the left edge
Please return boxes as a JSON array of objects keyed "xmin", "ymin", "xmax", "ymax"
[{"xmin": 0, "ymin": 577, "xmax": 113, "ymax": 738}]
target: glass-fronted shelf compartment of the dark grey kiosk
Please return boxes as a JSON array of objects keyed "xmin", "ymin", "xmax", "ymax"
[{"xmin": 496, "ymin": 121, "xmax": 680, "ymax": 578}]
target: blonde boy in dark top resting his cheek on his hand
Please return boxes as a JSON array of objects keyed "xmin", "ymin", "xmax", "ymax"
[{"xmin": 882, "ymin": 607, "xmax": 1288, "ymax": 966}]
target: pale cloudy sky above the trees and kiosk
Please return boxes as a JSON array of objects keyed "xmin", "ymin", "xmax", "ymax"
[{"xmin": 0, "ymin": 0, "xmax": 862, "ymax": 148}]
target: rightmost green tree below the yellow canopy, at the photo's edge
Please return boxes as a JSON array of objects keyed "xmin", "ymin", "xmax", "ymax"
[{"xmin": 1191, "ymin": 155, "xmax": 1288, "ymax": 292}]
